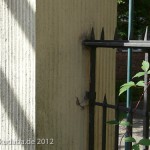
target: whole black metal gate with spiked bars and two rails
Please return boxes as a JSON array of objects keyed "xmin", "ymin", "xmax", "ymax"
[{"xmin": 82, "ymin": 29, "xmax": 150, "ymax": 150}]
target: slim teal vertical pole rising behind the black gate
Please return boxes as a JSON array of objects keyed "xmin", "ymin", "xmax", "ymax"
[{"xmin": 125, "ymin": 0, "xmax": 133, "ymax": 150}]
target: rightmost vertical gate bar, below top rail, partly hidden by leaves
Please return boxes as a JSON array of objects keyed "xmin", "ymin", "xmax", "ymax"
[{"xmin": 143, "ymin": 53, "xmax": 149, "ymax": 150}]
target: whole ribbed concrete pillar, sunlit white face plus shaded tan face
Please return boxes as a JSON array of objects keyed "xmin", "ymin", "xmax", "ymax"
[{"xmin": 0, "ymin": 0, "xmax": 116, "ymax": 150}]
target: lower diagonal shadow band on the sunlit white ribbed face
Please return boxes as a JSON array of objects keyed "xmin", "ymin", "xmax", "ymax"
[{"xmin": 0, "ymin": 70, "xmax": 35, "ymax": 150}]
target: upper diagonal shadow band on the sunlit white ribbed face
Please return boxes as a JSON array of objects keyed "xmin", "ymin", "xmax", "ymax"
[{"xmin": 4, "ymin": 0, "xmax": 35, "ymax": 48}]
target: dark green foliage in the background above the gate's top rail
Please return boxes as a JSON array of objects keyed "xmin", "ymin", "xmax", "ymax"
[{"xmin": 117, "ymin": 0, "xmax": 150, "ymax": 40}]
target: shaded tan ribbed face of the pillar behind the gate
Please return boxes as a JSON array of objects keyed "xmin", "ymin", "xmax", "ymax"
[{"xmin": 36, "ymin": 0, "xmax": 116, "ymax": 150}]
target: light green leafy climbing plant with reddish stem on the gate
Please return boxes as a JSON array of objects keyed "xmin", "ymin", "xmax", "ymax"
[{"xmin": 107, "ymin": 61, "xmax": 150, "ymax": 150}]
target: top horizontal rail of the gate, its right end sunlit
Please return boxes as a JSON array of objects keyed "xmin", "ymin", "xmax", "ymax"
[{"xmin": 82, "ymin": 40, "xmax": 150, "ymax": 48}]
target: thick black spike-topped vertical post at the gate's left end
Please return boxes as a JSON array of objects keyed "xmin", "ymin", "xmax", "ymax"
[{"xmin": 89, "ymin": 28, "xmax": 96, "ymax": 150}]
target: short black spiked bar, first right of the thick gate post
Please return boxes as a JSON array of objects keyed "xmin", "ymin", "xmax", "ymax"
[{"xmin": 102, "ymin": 95, "xmax": 107, "ymax": 150}]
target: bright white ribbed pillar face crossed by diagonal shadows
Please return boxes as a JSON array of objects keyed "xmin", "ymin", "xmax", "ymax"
[{"xmin": 0, "ymin": 0, "xmax": 35, "ymax": 150}]
